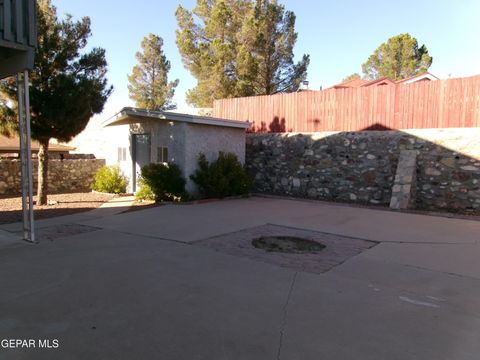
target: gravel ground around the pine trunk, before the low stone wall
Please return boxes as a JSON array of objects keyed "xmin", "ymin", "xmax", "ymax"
[{"xmin": 0, "ymin": 192, "xmax": 114, "ymax": 224}]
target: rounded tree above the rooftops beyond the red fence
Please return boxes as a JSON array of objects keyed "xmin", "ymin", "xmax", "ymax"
[{"xmin": 362, "ymin": 34, "xmax": 432, "ymax": 80}]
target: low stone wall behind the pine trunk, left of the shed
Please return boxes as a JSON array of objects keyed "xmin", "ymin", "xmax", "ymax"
[{"xmin": 0, "ymin": 159, "xmax": 105, "ymax": 194}]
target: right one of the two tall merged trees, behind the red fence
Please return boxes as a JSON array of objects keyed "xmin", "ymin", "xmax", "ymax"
[{"xmin": 237, "ymin": 0, "xmax": 310, "ymax": 95}]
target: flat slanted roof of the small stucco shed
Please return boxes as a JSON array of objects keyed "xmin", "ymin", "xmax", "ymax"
[{"xmin": 103, "ymin": 107, "xmax": 250, "ymax": 129}]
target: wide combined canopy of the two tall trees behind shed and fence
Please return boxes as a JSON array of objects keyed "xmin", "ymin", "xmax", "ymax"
[{"xmin": 176, "ymin": 0, "xmax": 309, "ymax": 107}]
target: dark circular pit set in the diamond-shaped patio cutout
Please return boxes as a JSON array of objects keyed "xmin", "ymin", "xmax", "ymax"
[{"xmin": 252, "ymin": 236, "xmax": 325, "ymax": 254}]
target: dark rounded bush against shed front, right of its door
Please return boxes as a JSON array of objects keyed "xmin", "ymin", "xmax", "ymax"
[{"xmin": 141, "ymin": 163, "xmax": 186, "ymax": 201}]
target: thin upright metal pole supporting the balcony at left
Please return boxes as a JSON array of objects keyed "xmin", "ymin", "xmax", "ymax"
[{"xmin": 17, "ymin": 71, "xmax": 35, "ymax": 242}]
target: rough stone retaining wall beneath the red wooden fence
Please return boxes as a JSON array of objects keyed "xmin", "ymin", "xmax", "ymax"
[{"xmin": 246, "ymin": 128, "xmax": 480, "ymax": 213}]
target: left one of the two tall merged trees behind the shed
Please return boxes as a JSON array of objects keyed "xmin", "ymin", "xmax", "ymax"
[{"xmin": 175, "ymin": 0, "xmax": 250, "ymax": 107}]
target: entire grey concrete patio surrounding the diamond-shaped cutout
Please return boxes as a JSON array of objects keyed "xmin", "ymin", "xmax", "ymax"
[{"xmin": 0, "ymin": 197, "xmax": 480, "ymax": 360}]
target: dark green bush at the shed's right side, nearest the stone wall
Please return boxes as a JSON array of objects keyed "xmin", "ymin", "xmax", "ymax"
[{"xmin": 190, "ymin": 152, "xmax": 252, "ymax": 198}]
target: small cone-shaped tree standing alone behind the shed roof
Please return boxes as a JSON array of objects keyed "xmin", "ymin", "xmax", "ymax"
[{"xmin": 128, "ymin": 34, "xmax": 178, "ymax": 110}]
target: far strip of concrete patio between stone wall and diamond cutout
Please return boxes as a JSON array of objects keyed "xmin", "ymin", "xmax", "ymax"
[{"xmin": 82, "ymin": 197, "xmax": 480, "ymax": 243}]
